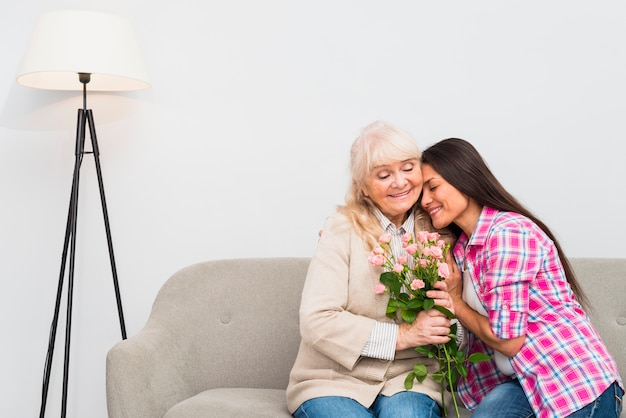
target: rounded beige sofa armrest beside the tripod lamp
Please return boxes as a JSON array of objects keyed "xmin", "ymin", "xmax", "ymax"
[{"xmin": 106, "ymin": 327, "xmax": 190, "ymax": 418}]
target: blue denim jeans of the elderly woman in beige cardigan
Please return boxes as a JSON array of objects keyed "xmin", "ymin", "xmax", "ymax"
[{"xmin": 293, "ymin": 392, "xmax": 441, "ymax": 418}]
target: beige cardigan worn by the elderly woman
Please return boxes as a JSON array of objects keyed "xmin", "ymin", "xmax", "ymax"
[{"xmin": 287, "ymin": 211, "xmax": 451, "ymax": 413}]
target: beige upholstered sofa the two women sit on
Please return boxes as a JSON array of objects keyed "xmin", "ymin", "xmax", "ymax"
[{"xmin": 107, "ymin": 258, "xmax": 626, "ymax": 418}]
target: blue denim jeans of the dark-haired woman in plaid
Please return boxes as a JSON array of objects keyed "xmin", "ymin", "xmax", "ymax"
[{"xmin": 472, "ymin": 380, "xmax": 622, "ymax": 418}]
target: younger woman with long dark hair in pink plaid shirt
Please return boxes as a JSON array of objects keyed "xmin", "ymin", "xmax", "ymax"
[{"xmin": 421, "ymin": 138, "xmax": 624, "ymax": 418}]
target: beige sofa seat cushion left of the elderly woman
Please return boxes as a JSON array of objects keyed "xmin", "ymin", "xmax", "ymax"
[{"xmin": 163, "ymin": 388, "xmax": 291, "ymax": 418}]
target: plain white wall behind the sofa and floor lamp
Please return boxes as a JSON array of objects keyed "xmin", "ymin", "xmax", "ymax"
[{"xmin": 0, "ymin": 0, "xmax": 626, "ymax": 418}]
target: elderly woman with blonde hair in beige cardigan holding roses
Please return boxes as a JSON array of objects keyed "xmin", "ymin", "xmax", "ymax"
[{"xmin": 287, "ymin": 121, "xmax": 453, "ymax": 418}]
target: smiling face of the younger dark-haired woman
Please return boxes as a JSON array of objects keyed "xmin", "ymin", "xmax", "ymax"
[{"xmin": 421, "ymin": 164, "xmax": 482, "ymax": 236}]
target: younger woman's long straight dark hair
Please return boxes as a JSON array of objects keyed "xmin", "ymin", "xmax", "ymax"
[{"xmin": 422, "ymin": 138, "xmax": 589, "ymax": 307}]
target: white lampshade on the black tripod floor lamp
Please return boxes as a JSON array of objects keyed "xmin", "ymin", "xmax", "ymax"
[{"xmin": 17, "ymin": 10, "xmax": 150, "ymax": 91}]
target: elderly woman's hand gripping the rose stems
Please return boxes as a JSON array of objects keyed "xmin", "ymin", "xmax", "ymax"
[{"xmin": 396, "ymin": 306, "xmax": 450, "ymax": 350}]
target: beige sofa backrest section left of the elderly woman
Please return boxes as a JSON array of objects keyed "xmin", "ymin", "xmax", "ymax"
[{"xmin": 146, "ymin": 258, "xmax": 310, "ymax": 394}]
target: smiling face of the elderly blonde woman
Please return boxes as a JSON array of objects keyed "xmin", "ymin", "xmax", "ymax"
[{"xmin": 363, "ymin": 159, "xmax": 422, "ymax": 227}]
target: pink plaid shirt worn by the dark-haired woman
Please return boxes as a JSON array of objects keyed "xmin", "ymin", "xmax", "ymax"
[{"xmin": 454, "ymin": 207, "xmax": 623, "ymax": 418}]
